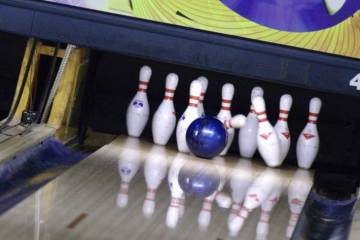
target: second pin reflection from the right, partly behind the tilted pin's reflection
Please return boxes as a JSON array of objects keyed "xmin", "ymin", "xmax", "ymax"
[{"xmin": 256, "ymin": 182, "xmax": 283, "ymax": 240}]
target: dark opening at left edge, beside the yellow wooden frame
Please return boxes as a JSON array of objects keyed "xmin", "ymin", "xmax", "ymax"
[{"xmin": 0, "ymin": 32, "xmax": 27, "ymax": 119}]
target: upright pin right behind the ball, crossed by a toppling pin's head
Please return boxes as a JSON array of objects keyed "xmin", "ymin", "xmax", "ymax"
[{"xmin": 216, "ymin": 83, "xmax": 235, "ymax": 156}]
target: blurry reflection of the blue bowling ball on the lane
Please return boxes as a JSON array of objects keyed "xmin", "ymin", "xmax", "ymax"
[{"xmin": 178, "ymin": 163, "xmax": 220, "ymax": 198}]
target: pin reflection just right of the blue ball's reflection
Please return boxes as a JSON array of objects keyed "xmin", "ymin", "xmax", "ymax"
[{"xmin": 198, "ymin": 157, "xmax": 227, "ymax": 231}]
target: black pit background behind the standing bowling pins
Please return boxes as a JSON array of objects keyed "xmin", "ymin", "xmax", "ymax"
[{"xmin": 91, "ymin": 53, "xmax": 360, "ymax": 170}]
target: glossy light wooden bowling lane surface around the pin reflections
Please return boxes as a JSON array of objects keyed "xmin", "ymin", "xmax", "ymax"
[{"xmin": 0, "ymin": 137, "xmax": 360, "ymax": 240}]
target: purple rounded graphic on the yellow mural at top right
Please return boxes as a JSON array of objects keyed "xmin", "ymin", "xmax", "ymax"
[{"xmin": 221, "ymin": 0, "xmax": 360, "ymax": 32}]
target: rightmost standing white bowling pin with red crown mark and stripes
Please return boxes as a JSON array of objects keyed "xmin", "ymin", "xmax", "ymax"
[{"xmin": 296, "ymin": 98, "xmax": 321, "ymax": 169}]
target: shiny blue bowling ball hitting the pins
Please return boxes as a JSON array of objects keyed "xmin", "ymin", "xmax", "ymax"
[{"xmin": 186, "ymin": 117, "xmax": 227, "ymax": 158}]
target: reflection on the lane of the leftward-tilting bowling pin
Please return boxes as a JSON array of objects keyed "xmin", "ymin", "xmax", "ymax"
[{"xmin": 229, "ymin": 168, "xmax": 282, "ymax": 236}]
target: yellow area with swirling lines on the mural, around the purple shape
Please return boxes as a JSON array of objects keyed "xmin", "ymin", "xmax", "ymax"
[{"xmin": 52, "ymin": 0, "xmax": 360, "ymax": 58}]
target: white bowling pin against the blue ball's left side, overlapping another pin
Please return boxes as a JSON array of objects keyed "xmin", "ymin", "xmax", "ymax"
[{"xmin": 176, "ymin": 80, "xmax": 201, "ymax": 153}]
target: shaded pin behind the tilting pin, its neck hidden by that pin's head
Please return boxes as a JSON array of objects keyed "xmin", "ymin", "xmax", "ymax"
[{"xmin": 238, "ymin": 87, "xmax": 264, "ymax": 158}]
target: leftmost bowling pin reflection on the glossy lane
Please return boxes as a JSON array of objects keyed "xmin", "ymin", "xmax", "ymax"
[{"xmin": 117, "ymin": 137, "xmax": 141, "ymax": 208}]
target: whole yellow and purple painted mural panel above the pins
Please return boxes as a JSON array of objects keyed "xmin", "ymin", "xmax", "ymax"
[{"xmin": 46, "ymin": 0, "xmax": 360, "ymax": 58}]
